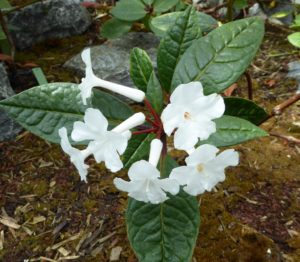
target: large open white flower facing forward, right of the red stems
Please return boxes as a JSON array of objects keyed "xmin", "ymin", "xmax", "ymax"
[{"xmin": 161, "ymin": 82, "xmax": 225, "ymax": 150}]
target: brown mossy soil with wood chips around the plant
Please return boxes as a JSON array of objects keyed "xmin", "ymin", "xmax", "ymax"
[{"xmin": 0, "ymin": 2, "xmax": 300, "ymax": 262}]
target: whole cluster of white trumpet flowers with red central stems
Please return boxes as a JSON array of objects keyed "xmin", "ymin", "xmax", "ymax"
[{"xmin": 59, "ymin": 49, "xmax": 239, "ymax": 204}]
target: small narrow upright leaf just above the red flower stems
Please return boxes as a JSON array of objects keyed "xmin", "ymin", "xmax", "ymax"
[{"xmin": 146, "ymin": 72, "xmax": 163, "ymax": 113}]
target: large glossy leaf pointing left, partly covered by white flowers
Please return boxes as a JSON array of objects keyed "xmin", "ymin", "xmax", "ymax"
[{"xmin": 0, "ymin": 83, "xmax": 132, "ymax": 143}]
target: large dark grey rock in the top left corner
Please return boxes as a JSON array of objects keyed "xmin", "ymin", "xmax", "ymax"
[{"xmin": 8, "ymin": 0, "xmax": 91, "ymax": 50}]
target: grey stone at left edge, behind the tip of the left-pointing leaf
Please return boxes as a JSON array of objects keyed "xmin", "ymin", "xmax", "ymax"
[{"xmin": 0, "ymin": 63, "xmax": 22, "ymax": 141}]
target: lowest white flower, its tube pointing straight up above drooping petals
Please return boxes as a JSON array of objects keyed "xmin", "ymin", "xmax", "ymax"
[{"xmin": 114, "ymin": 139, "xmax": 179, "ymax": 204}]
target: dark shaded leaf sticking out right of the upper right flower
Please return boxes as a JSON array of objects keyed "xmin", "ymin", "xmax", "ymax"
[{"xmin": 224, "ymin": 97, "xmax": 269, "ymax": 125}]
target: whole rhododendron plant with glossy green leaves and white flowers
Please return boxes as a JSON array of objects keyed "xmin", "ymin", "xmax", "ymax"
[{"xmin": 0, "ymin": 6, "xmax": 267, "ymax": 262}]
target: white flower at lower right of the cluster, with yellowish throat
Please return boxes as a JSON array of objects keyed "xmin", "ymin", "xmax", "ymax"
[{"xmin": 170, "ymin": 144, "xmax": 239, "ymax": 196}]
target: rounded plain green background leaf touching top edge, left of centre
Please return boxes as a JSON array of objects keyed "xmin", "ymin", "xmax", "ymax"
[{"xmin": 111, "ymin": 0, "xmax": 147, "ymax": 22}]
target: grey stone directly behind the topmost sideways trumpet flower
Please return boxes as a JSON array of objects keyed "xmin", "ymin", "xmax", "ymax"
[{"xmin": 64, "ymin": 32, "xmax": 159, "ymax": 87}]
